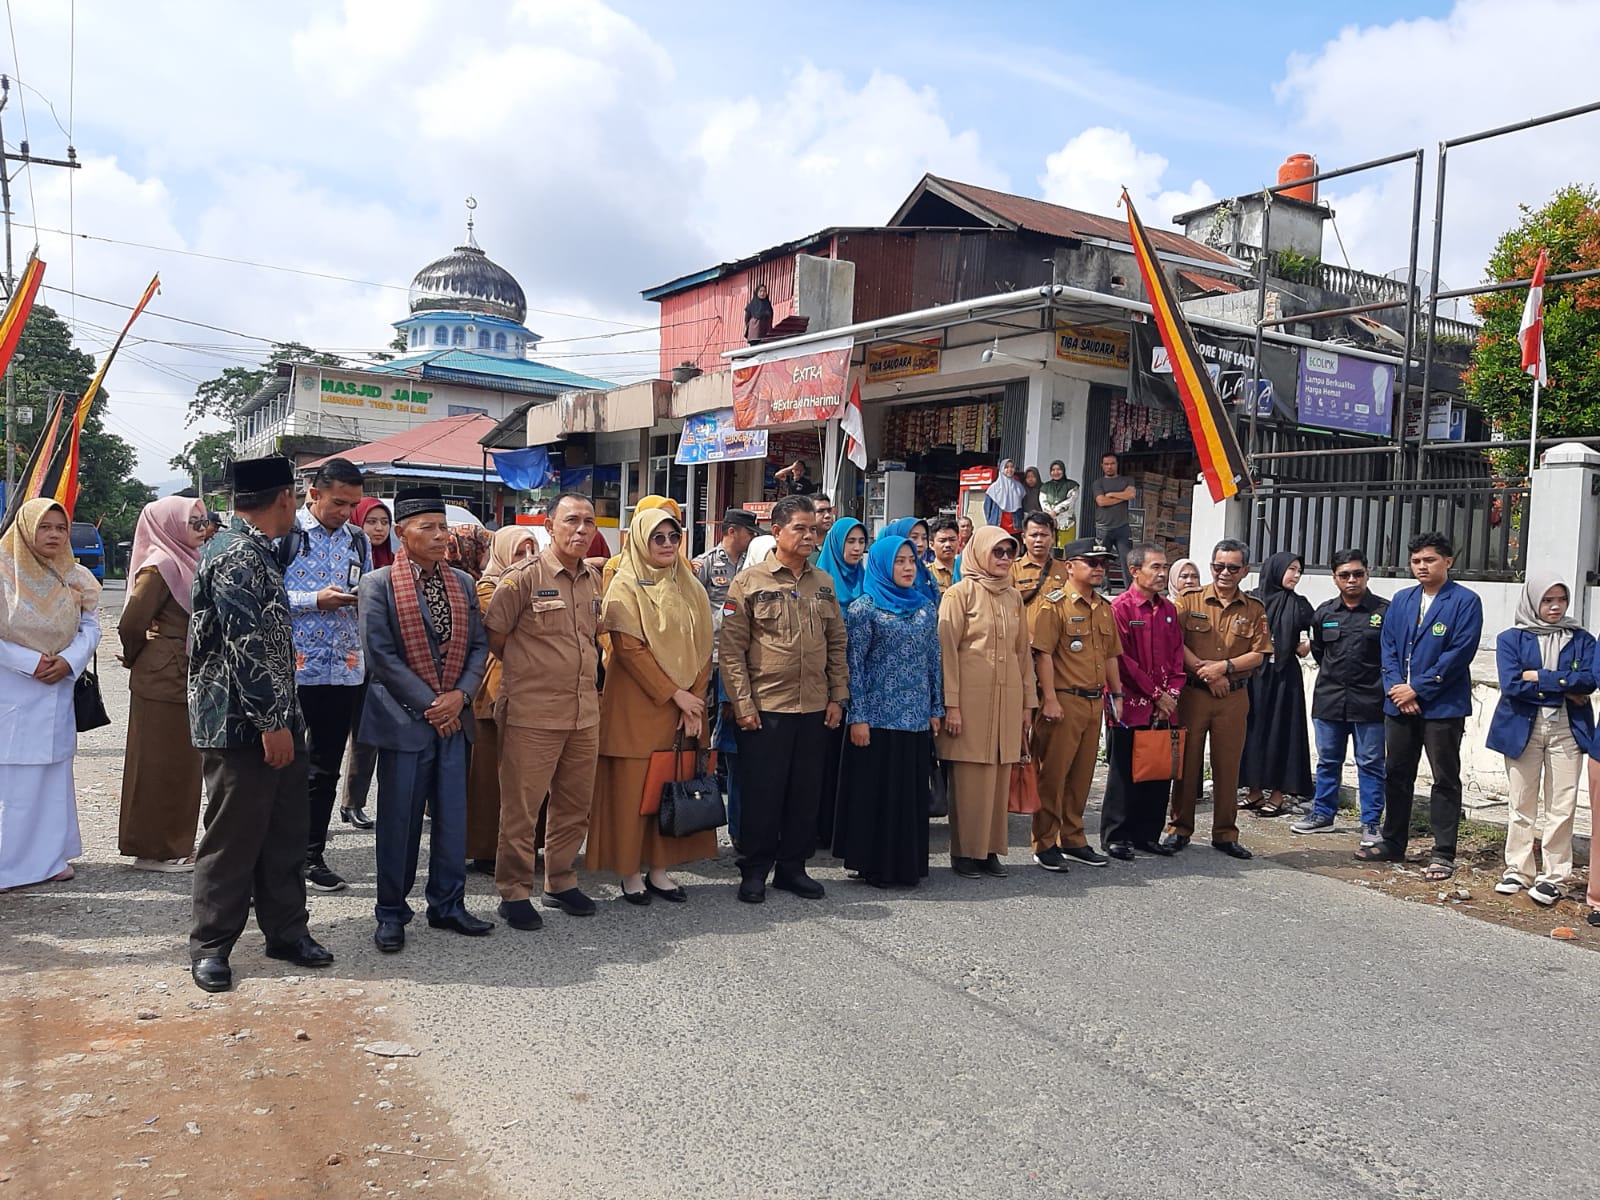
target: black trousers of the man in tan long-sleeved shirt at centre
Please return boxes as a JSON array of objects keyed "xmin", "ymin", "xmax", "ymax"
[{"xmin": 733, "ymin": 712, "xmax": 832, "ymax": 878}]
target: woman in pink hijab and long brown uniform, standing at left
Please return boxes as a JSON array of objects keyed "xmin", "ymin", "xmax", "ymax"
[{"xmin": 117, "ymin": 496, "xmax": 211, "ymax": 872}]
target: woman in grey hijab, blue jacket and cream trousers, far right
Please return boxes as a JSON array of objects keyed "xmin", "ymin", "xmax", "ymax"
[{"xmin": 1488, "ymin": 573, "xmax": 1595, "ymax": 907}]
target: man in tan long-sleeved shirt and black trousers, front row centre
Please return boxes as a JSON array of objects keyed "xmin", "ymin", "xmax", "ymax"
[{"xmin": 718, "ymin": 496, "xmax": 850, "ymax": 904}]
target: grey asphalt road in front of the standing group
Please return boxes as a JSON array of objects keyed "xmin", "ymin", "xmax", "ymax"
[{"xmin": 28, "ymin": 594, "xmax": 1600, "ymax": 1200}]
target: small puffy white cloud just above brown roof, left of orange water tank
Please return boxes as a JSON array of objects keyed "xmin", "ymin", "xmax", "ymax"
[{"xmin": 1038, "ymin": 126, "xmax": 1216, "ymax": 229}]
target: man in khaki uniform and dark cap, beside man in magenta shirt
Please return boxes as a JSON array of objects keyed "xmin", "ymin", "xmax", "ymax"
[{"xmin": 1029, "ymin": 540, "xmax": 1122, "ymax": 870}]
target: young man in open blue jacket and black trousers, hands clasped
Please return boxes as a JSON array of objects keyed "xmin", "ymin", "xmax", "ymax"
[{"xmin": 1355, "ymin": 533, "xmax": 1483, "ymax": 883}]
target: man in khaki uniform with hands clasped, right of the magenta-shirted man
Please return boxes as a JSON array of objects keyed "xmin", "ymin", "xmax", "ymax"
[{"xmin": 1162, "ymin": 538, "xmax": 1272, "ymax": 858}]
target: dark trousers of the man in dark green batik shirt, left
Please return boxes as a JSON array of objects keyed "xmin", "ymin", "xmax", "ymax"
[{"xmin": 189, "ymin": 738, "xmax": 307, "ymax": 960}]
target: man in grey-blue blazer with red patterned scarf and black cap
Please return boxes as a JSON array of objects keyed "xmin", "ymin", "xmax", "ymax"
[{"xmin": 360, "ymin": 488, "xmax": 494, "ymax": 954}]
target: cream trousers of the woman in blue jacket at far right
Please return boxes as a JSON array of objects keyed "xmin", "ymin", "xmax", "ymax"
[{"xmin": 1506, "ymin": 706, "xmax": 1584, "ymax": 888}]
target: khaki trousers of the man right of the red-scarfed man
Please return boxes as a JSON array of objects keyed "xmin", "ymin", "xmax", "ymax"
[{"xmin": 494, "ymin": 725, "xmax": 600, "ymax": 901}]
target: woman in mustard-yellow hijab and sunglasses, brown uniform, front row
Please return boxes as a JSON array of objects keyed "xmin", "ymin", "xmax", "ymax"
[{"xmin": 584, "ymin": 509, "xmax": 717, "ymax": 906}]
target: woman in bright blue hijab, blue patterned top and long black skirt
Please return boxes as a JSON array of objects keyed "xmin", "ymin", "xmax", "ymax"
[{"xmin": 834, "ymin": 536, "xmax": 944, "ymax": 888}]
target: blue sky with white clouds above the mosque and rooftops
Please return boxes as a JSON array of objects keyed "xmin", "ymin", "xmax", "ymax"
[{"xmin": 5, "ymin": 0, "xmax": 1600, "ymax": 480}]
